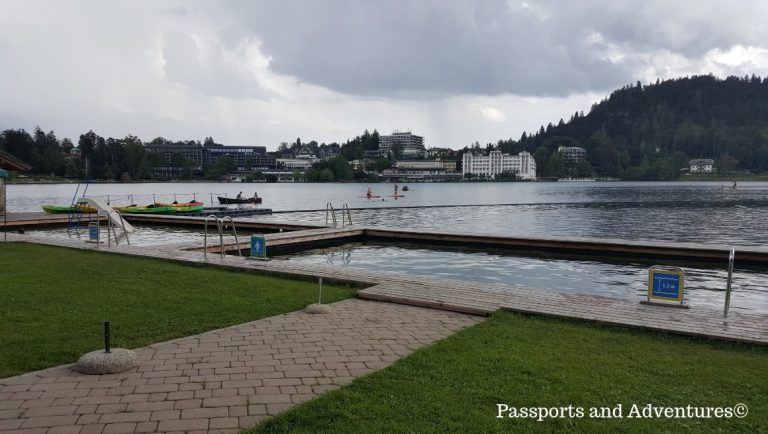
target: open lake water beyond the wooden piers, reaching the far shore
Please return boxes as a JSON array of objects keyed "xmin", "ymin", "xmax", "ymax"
[{"xmin": 7, "ymin": 182, "xmax": 768, "ymax": 246}]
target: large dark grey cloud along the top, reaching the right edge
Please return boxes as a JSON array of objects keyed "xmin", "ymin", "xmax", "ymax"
[{"xmin": 213, "ymin": 0, "xmax": 765, "ymax": 98}]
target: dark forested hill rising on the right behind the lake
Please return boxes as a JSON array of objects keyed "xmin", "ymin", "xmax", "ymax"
[{"xmin": 517, "ymin": 76, "xmax": 768, "ymax": 179}]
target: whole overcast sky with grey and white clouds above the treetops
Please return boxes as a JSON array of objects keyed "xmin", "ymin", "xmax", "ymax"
[{"xmin": 0, "ymin": 0, "xmax": 768, "ymax": 150}]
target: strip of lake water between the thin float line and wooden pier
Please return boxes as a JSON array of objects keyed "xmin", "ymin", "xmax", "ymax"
[{"xmin": 256, "ymin": 202, "xmax": 768, "ymax": 246}]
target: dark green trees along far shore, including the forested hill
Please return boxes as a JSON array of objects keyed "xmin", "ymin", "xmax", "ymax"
[{"xmin": 6, "ymin": 75, "xmax": 768, "ymax": 181}]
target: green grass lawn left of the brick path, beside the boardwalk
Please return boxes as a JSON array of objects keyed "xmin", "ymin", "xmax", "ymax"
[{"xmin": 0, "ymin": 243, "xmax": 357, "ymax": 378}]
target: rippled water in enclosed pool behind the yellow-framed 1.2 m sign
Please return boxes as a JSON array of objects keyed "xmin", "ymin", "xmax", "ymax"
[{"xmin": 283, "ymin": 243, "xmax": 768, "ymax": 312}]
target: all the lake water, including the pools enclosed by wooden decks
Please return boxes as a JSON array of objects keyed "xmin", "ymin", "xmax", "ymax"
[{"xmin": 8, "ymin": 182, "xmax": 768, "ymax": 312}]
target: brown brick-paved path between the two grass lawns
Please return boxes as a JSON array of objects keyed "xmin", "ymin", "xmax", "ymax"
[{"xmin": 0, "ymin": 299, "xmax": 482, "ymax": 434}]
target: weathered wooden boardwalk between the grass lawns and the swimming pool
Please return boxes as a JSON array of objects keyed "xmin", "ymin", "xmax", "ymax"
[{"xmin": 0, "ymin": 227, "xmax": 768, "ymax": 344}]
